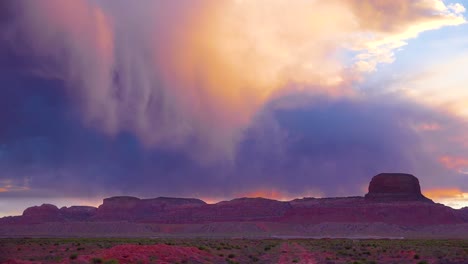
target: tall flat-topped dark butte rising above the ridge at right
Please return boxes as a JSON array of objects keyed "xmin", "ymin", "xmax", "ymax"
[{"xmin": 365, "ymin": 173, "xmax": 433, "ymax": 203}]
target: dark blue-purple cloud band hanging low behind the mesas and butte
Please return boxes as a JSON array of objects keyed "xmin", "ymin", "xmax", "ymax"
[{"xmin": 0, "ymin": 56, "xmax": 462, "ymax": 201}]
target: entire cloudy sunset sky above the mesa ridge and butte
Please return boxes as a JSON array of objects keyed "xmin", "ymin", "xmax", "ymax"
[{"xmin": 0, "ymin": 0, "xmax": 468, "ymax": 216}]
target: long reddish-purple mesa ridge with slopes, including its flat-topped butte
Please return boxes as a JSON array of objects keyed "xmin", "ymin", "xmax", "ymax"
[{"xmin": 0, "ymin": 174, "xmax": 468, "ymax": 237}]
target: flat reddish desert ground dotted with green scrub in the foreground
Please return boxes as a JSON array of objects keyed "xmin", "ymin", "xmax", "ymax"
[{"xmin": 0, "ymin": 238, "xmax": 468, "ymax": 264}]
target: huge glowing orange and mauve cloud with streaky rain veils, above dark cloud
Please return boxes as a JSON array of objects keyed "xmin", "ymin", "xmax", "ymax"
[{"xmin": 5, "ymin": 0, "xmax": 465, "ymax": 160}]
